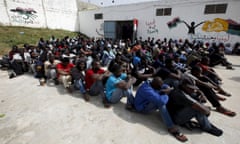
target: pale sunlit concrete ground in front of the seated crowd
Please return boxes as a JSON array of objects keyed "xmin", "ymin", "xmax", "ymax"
[{"xmin": 0, "ymin": 56, "xmax": 240, "ymax": 144}]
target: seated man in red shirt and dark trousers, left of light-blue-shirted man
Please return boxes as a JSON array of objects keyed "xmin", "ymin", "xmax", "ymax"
[{"xmin": 85, "ymin": 59, "xmax": 110, "ymax": 107}]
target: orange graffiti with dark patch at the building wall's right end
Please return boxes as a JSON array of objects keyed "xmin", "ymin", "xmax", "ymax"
[{"xmin": 202, "ymin": 18, "xmax": 240, "ymax": 36}]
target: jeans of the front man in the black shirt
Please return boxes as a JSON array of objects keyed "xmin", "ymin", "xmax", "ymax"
[{"xmin": 173, "ymin": 107, "xmax": 212, "ymax": 130}]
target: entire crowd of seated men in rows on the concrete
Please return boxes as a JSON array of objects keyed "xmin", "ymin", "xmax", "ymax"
[{"xmin": 3, "ymin": 36, "xmax": 236, "ymax": 141}]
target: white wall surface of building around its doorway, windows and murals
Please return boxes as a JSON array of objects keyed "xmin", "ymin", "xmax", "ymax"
[{"xmin": 79, "ymin": 0, "xmax": 240, "ymax": 43}]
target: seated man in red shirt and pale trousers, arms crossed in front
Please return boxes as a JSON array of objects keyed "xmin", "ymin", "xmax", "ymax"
[{"xmin": 56, "ymin": 57, "xmax": 74, "ymax": 93}]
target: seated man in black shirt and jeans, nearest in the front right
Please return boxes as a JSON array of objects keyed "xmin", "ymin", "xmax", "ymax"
[{"xmin": 167, "ymin": 76, "xmax": 223, "ymax": 136}]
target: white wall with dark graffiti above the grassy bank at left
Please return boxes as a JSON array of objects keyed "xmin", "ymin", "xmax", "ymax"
[{"xmin": 0, "ymin": 0, "xmax": 79, "ymax": 31}]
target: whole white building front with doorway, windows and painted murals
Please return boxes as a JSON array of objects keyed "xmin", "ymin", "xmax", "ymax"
[{"xmin": 79, "ymin": 0, "xmax": 240, "ymax": 43}]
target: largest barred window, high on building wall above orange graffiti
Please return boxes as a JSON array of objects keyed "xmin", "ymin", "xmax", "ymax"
[{"xmin": 204, "ymin": 4, "xmax": 227, "ymax": 14}]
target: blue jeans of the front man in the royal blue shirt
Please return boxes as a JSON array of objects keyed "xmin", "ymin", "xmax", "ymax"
[{"xmin": 142, "ymin": 103, "xmax": 174, "ymax": 128}]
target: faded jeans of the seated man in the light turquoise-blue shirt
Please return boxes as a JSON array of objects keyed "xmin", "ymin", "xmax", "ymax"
[{"xmin": 108, "ymin": 88, "xmax": 134, "ymax": 104}]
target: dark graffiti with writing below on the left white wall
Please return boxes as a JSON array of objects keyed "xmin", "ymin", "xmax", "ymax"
[{"xmin": 10, "ymin": 7, "xmax": 39, "ymax": 24}]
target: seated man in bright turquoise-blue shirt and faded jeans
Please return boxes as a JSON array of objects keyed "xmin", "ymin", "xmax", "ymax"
[{"xmin": 106, "ymin": 64, "xmax": 136, "ymax": 108}]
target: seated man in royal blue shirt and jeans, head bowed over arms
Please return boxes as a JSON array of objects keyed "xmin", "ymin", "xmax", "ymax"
[{"xmin": 134, "ymin": 77, "xmax": 187, "ymax": 142}]
